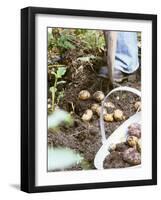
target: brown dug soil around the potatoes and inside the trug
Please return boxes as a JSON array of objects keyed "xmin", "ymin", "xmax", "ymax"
[{"xmin": 48, "ymin": 51, "xmax": 141, "ymax": 170}]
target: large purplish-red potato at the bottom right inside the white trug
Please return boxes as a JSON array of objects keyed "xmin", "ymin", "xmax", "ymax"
[{"xmin": 123, "ymin": 148, "xmax": 141, "ymax": 165}]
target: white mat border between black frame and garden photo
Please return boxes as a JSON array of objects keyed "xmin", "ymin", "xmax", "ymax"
[{"xmin": 35, "ymin": 14, "xmax": 152, "ymax": 186}]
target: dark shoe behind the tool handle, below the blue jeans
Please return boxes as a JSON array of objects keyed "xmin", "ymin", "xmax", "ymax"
[{"xmin": 98, "ymin": 66, "xmax": 128, "ymax": 83}]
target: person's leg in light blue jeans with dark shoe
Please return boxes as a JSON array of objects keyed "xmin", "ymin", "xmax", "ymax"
[{"xmin": 98, "ymin": 31, "xmax": 139, "ymax": 83}]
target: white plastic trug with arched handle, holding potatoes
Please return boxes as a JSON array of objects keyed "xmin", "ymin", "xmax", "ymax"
[{"xmin": 94, "ymin": 86, "xmax": 141, "ymax": 169}]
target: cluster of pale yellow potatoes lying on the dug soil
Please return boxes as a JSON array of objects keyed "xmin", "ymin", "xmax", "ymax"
[{"xmin": 78, "ymin": 90, "xmax": 125, "ymax": 122}]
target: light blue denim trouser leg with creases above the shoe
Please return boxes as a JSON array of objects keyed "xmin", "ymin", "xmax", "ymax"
[{"xmin": 115, "ymin": 31, "xmax": 139, "ymax": 73}]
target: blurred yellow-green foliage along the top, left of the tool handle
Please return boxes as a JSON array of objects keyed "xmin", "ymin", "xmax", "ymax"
[{"xmin": 48, "ymin": 28, "xmax": 105, "ymax": 56}]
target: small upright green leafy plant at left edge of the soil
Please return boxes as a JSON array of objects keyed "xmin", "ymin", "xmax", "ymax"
[{"xmin": 50, "ymin": 67, "xmax": 66, "ymax": 111}]
